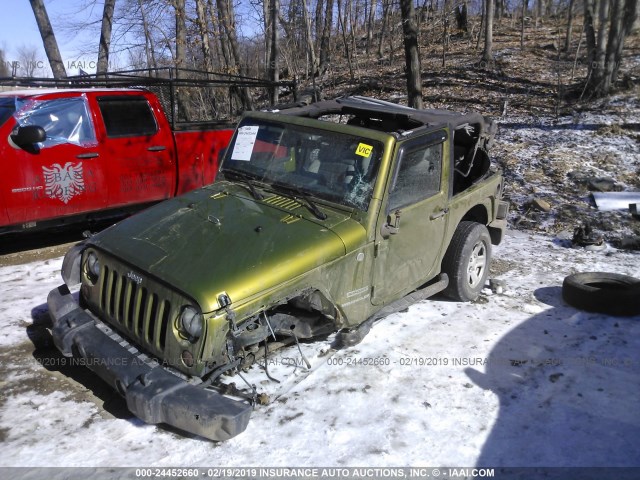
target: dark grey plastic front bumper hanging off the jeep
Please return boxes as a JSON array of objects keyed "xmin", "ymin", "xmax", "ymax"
[{"xmin": 47, "ymin": 285, "xmax": 252, "ymax": 441}]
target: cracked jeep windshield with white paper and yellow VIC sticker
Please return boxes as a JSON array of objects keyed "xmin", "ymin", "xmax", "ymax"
[{"xmin": 222, "ymin": 119, "xmax": 383, "ymax": 210}]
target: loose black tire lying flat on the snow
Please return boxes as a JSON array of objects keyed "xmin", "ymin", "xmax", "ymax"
[{"xmin": 562, "ymin": 272, "xmax": 640, "ymax": 316}]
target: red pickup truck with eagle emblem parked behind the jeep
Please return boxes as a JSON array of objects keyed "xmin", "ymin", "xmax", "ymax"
[{"xmin": 0, "ymin": 88, "xmax": 233, "ymax": 235}]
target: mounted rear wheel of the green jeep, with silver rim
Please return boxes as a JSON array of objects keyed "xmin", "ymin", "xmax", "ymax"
[{"xmin": 442, "ymin": 221, "xmax": 491, "ymax": 302}]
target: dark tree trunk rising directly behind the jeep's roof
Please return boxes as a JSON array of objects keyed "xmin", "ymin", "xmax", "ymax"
[{"xmin": 400, "ymin": 0, "xmax": 422, "ymax": 108}]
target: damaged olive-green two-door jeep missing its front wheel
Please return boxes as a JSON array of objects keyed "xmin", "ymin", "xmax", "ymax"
[{"xmin": 48, "ymin": 97, "xmax": 508, "ymax": 440}]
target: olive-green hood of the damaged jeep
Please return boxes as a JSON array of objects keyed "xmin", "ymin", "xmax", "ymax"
[{"xmin": 90, "ymin": 182, "xmax": 365, "ymax": 312}]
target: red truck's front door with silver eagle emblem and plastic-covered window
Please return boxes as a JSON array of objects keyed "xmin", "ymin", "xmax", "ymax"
[{"xmin": 0, "ymin": 96, "xmax": 106, "ymax": 228}]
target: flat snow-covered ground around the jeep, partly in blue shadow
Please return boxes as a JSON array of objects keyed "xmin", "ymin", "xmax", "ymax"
[{"xmin": 0, "ymin": 231, "xmax": 640, "ymax": 467}]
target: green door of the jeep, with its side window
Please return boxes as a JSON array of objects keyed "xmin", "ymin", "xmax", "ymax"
[{"xmin": 372, "ymin": 130, "xmax": 449, "ymax": 305}]
